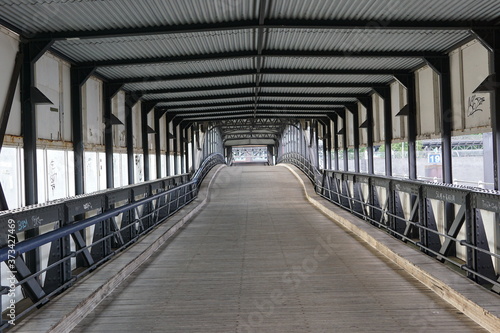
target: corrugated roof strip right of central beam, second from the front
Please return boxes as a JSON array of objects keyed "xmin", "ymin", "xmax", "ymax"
[{"xmin": 267, "ymin": 28, "xmax": 470, "ymax": 52}]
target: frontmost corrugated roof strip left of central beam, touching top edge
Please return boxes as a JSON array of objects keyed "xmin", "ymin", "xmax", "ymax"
[{"xmin": 0, "ymin": 0, "xmax": 259, "ymax": 33}]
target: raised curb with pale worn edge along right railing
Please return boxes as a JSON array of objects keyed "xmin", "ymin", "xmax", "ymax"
[{"xmin": 279, "ymin": 164, "xmax": 500, "ymax": 333}]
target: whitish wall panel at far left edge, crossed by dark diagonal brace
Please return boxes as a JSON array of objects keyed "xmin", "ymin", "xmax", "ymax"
[{"xmin": 0, "ymin": 28, "xmax": 21, "ymax": 136}]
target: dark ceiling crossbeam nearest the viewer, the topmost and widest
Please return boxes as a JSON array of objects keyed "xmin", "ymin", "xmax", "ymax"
[{"xmin": 24, "ymin": 19, "xmax": 492, "ymax": 40}]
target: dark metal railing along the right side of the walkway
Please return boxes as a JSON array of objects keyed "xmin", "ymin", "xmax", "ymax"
[{"xmin": 279, "ymin": 153, "xmax": 500, "ymax": 293}]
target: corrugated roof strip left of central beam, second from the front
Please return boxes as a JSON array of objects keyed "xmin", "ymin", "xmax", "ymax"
[{"xmin": 53, "ymin": 30, "xmax": 257, "ymax": 62}]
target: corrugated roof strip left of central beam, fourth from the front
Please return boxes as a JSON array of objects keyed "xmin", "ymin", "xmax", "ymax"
[{"xmin": 123, "ymin": 75, "xmax": 255, "ymax": 91}]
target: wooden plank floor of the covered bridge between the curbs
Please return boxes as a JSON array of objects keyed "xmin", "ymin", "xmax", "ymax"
[{"xmin": 73, "ymin": 166, "xmax": 483, "ymax": 333}]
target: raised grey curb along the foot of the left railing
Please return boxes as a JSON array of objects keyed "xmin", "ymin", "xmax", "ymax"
[{"xmin": 9, "ymin": 165, "xmax": 225, "ymax": 333}]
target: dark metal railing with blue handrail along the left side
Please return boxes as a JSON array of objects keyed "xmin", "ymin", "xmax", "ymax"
[{"xmin": 0, "ymin": 154, "xmax": 224, "ymax": 331}]
